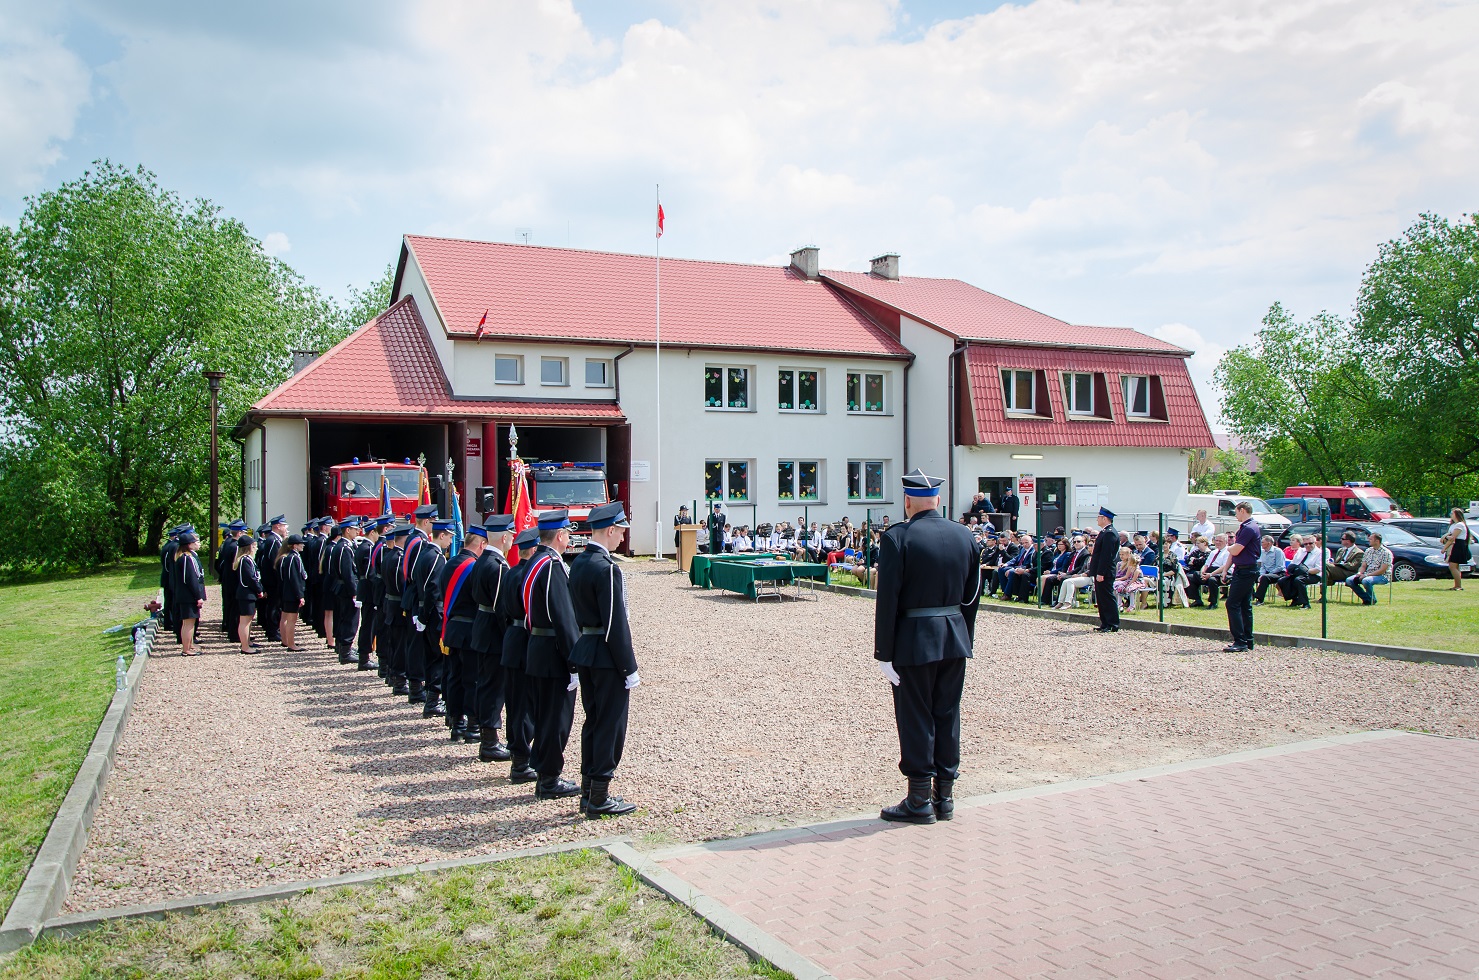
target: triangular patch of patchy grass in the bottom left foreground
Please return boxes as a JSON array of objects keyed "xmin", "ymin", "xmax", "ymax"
[{"xmin": 0, "ymin": 851, "xmax": 790, "ymax": 980}]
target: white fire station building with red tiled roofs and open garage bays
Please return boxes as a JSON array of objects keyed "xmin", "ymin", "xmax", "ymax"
[{"xmin": 234, "ymin": 235, "xmax": 1213, "ymax": 553}]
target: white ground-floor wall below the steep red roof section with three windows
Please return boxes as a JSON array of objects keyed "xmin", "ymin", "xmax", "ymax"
[{"xmin": 955, "ymin": 446, "xmax": 1186, "ymax": 532}]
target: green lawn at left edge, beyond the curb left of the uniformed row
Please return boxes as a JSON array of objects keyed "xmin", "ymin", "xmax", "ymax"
[{"xmin": 0, "ymin": 559, "xmax": 158, "ymax": 913}]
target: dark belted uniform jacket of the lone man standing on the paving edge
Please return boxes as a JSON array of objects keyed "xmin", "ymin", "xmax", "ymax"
[{"xmin": 873, "ymin": 510, "xmax": 981, "ymax": 667}]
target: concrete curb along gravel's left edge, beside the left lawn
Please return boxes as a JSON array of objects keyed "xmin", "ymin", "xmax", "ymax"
[{"xmin": 0, "ymin": 619, "xmax": 158, "ymax": 953}]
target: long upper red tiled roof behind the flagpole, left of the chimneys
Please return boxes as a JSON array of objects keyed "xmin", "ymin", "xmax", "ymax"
[{"xmin": 405, "ymin": 235, "xmax": 910, "ymax": 358}]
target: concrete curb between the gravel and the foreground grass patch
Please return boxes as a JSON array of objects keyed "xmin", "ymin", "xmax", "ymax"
[{"xmin": 40, "ymin": 837, "xmax": 627, "ymax": 937}]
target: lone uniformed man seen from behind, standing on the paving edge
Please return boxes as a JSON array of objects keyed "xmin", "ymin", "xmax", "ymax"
[{"xmin": 873, "ymin": 470, "xmax": 981, "ymax": 823}]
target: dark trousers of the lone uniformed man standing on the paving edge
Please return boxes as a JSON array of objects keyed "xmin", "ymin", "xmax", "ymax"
[{"xmin": 893, "ymin": 658, "xmax": 966, "ymax": 779}]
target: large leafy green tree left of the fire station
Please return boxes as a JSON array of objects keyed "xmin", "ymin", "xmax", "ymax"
[{"xmin": 0, "ymin": 161, "xmax": 387, "ymax": 566}]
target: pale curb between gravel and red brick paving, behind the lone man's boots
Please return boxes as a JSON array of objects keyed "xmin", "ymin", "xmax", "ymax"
[{"xmin": 648, "ymin": 729, "xmax": 1408, "ymax": 862}]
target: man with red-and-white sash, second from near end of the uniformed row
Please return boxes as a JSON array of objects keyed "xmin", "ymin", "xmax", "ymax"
[{"xmin": 524, "ymin": 510, "xmax": 580, "ymax": 800}]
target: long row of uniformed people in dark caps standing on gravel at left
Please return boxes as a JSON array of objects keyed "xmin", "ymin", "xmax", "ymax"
[{"xmin": 160, "ymin": 503, "xmax": 642, "ymax": 817}]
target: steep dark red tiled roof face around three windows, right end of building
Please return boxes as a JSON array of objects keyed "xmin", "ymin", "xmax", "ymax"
[{"xmin": 966, "ymin": 344, "xmax": 1214, "ymax": 449}]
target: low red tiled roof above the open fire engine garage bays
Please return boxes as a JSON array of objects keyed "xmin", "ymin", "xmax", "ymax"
[{"xmin": 251, "ymin": 297, "xmax": 624, "ymax": 421}]
